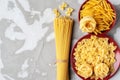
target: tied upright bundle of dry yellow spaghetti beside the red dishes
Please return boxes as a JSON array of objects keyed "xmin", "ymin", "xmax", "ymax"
[{"xmin": 54, "ymin": 16, "xmax": 73, "ymax": 80}]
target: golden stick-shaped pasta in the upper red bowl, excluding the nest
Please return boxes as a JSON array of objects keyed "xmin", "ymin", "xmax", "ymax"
[{"xmin": 80, "ymin": 0, "xmax": 116, "ymax": 34}]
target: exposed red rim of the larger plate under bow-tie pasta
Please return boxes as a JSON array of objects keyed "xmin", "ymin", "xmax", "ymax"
[{"xmin": 70, "ymin": 34, "xmax": 120, "ymax": 80}]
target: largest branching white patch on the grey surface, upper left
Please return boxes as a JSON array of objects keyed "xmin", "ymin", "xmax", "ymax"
[{"xmin": 0, "ymin": 0, "xmax": 54, "ymax": 54}]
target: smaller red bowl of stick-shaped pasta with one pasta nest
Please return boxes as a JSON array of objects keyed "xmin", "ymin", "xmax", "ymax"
[{"xmin": 78, "ymin": 0, "xmax": 116, "ymax": 35}]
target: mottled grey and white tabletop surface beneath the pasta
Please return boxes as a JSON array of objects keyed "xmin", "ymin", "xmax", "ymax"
[{"xmin": 0, "ymin": 0, "xmax": 120, "ymax": 80}]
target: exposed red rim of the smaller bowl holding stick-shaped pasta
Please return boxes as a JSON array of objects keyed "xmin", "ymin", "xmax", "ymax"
[{"xmin": 78, "ymin": 0, "xmax": 116, "ymax": 34}]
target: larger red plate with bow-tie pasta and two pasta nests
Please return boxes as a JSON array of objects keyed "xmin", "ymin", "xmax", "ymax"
[{"xmin": 71, "ymin": 34, "xmax": 120, "ymax": 80}]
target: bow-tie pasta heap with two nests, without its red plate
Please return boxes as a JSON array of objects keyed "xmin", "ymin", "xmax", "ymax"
[{"xmin": 73, "ymin": 35, "xmax": 116, "ymax": 80}]
